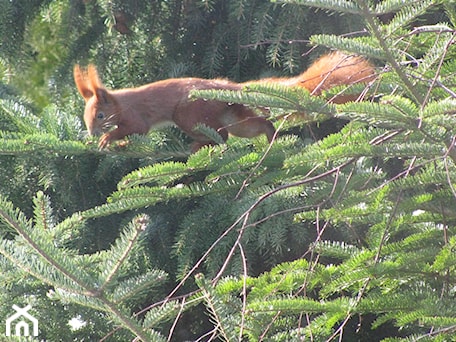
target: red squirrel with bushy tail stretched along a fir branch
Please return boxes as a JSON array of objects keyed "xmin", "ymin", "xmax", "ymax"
[{"xmin": 74, "ymin": 52, "xmax": 374, "ymax": 151}]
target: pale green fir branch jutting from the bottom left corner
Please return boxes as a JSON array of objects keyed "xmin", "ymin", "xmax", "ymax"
[{"xmin": 0, "ymin": 193, "xmax": 174, "ymax": 341}]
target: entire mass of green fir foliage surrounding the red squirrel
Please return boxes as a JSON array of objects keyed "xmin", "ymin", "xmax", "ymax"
[{"xmin": 0, "ymin": 0, "xmax": 456, "ymax": 341}]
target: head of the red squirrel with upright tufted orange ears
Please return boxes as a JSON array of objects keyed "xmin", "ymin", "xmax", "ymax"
[{"xmin": 73, "ymin": 64, "xmax": 118, "ymax": 135}]
